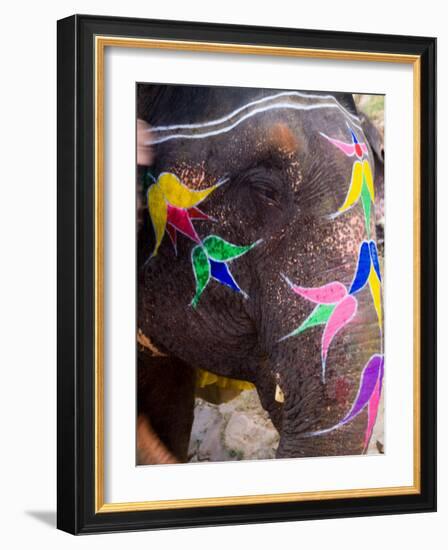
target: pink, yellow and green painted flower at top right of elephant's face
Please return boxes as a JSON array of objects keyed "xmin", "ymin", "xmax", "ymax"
[{"xmin": 321, "ymin": 128, "xmax": 375, "ymax": 236}]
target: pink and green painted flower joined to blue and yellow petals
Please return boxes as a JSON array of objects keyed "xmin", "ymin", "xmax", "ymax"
[{"xmin": 280, "ymin": 241, "xmax": 382, "ymax": 381}]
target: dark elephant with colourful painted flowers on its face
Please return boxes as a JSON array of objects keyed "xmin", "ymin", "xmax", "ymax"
[{"xmin": 137, "ymin": 84, "xmax": 384, "ymax": 463}]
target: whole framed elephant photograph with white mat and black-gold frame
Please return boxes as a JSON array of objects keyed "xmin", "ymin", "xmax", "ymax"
[{"xmin": 58, "ymin": 16, "xmax": 436, "ymax": 534}]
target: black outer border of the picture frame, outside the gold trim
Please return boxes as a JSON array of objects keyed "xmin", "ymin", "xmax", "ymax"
[{"xmin": 57, "ymin": 15, "xmax": 436, "ymax": 534}]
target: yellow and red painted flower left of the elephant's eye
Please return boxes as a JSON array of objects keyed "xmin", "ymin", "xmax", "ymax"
[{"xmin": 147, "ymin": 172, "xmax": 223, "ymax": 256}]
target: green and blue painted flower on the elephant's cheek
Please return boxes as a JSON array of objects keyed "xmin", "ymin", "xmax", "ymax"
[{"xmin": 191, "ymin": 235, "xmax": 261, "ymax": 308}]
